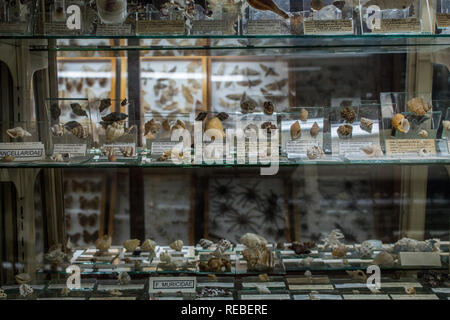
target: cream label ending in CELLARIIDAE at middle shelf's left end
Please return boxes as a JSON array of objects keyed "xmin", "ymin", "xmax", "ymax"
[{"xmin": 0, "ymin": 142, "xmax": 45, "ymax": 161}]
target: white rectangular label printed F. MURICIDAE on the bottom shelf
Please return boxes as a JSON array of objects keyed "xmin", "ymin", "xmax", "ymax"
[{"xmin": 149, "ymin": 277, "xmax": 197, "ymax": 293}]
